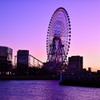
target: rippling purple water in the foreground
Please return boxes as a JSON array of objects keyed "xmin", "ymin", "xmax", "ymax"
[{"xmin": 0, "ymin": 80, "xmax": 100, "ymax": 100}]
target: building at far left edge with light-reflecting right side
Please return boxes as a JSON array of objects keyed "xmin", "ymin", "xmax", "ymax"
[{"xmin": 0, "ymin": 46, "xmax": 13, "ymax": 74}]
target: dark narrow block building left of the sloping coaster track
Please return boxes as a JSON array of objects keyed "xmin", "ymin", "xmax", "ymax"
[{"xmin": 17, "ymin": 50, "xmax": 29, "ymax": 74}]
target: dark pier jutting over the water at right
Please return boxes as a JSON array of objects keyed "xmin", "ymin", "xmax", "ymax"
[{"xmin": 59, "ymin": 72, "xmax": 100, "ymax": 88}]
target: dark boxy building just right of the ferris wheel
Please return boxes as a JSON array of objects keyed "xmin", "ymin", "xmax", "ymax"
[{"xmin": 68, "ymin": 56, "xmax": 83, "ymax": 72}]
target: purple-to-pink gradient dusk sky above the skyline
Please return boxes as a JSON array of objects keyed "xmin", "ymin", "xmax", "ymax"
[{"xmin": 0, "ymin": 0, "xmax": 100, "ymax": 71}]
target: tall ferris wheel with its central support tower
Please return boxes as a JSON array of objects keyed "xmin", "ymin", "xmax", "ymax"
[{"xmin": 46, "ymin": 7, "xmax": 71, "ymax": 64}]
